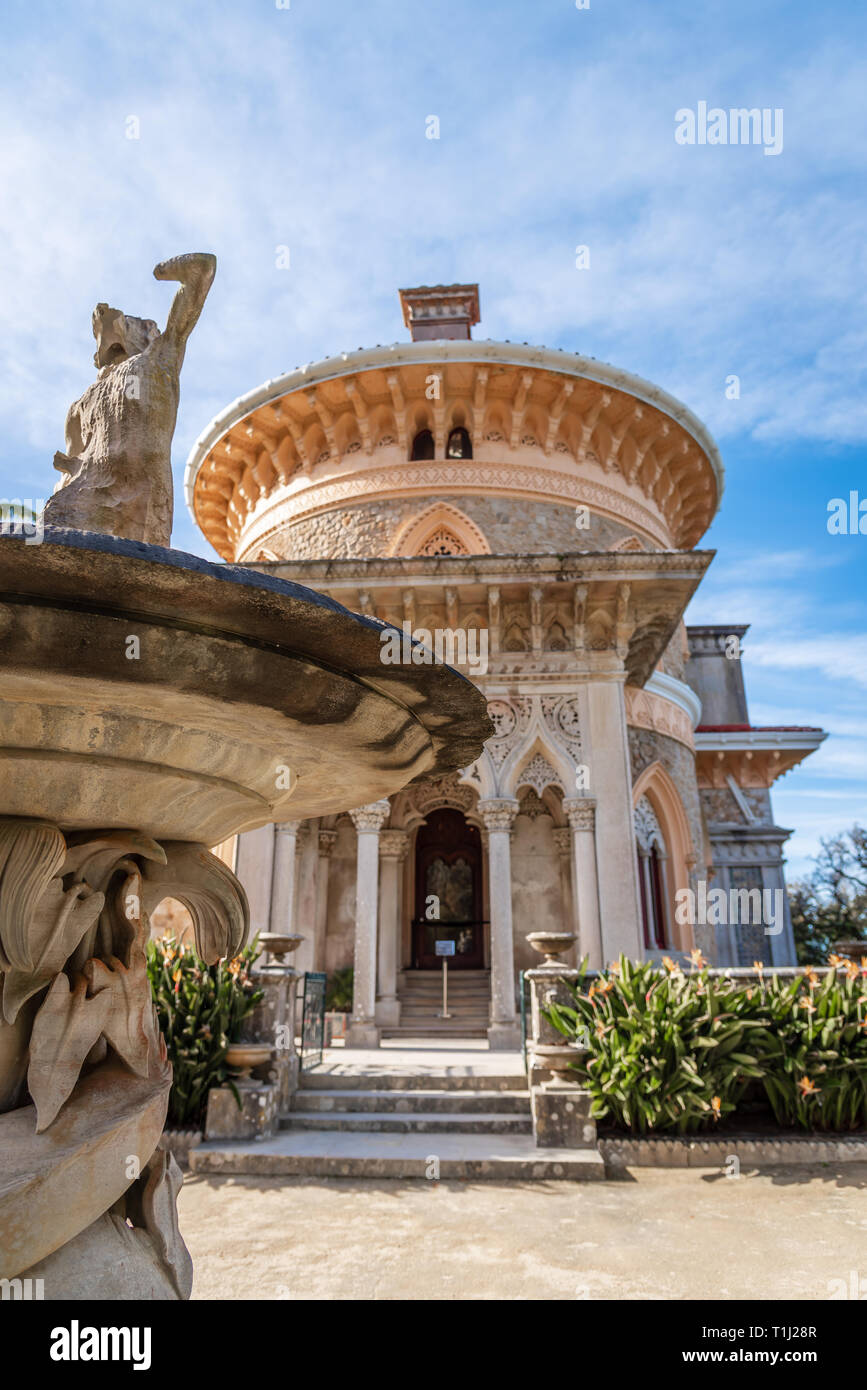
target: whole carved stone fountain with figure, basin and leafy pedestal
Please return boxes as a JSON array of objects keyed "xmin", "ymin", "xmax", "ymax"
[{"xmin": 0, "ymin": 254, "xmax": 489, "ymax": 1298}]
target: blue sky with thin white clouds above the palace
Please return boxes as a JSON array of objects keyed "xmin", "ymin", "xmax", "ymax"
[{"xmin": 0, "ymin": 0, "xmax": 867, "ymax": 873}]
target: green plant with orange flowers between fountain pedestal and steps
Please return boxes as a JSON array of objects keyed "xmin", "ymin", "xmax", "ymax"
[{"xmin": 147, "ymin": 937, "xmax": 263, "ymax": 1125}]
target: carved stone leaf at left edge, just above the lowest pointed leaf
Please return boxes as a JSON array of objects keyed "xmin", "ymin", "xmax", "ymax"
[{"xmin": 3, "ymin": 878, "xmax": 104, "ymax": 1023}]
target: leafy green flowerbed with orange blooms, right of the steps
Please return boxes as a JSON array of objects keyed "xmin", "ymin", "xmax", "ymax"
[{"xmin": 543, "ymin": 952, "xmax": 867, "ymax": 1134}]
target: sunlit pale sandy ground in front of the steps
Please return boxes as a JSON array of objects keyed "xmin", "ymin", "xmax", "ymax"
[{"xmin": 179, "ymin": 1162, "xmax": 867, "ymax": 1300}]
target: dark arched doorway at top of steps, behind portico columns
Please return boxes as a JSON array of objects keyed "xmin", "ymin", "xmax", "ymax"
[{"xmin": 413, "ymin": 806, "xmax": 485, "ymax": 970}]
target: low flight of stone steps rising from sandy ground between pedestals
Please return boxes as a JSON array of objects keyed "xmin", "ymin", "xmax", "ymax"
[{"xmin": 190, "ymin": 1069, "xmax": 604, "ymax": 1180}]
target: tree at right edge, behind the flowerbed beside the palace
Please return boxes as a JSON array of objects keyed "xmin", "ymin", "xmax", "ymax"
[{"xmin": 789, "ymin": 826, "xmax": 867, "ymax": 965}]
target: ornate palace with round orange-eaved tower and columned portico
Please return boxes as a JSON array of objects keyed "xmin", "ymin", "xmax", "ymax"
[{"xmin": 186, "ymin": 285, "xmax": 825, "ymax": 1048}]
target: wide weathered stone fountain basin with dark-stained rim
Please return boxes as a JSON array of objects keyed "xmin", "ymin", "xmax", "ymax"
[{"xmin": 0, "ymin": 528, "xmax": 490, "ymax": 845}]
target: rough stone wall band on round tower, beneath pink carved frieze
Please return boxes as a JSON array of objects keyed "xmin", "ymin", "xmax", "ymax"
[{"xmin": 254, "ymin": 495, "xmax": 644, "ymax": 560}]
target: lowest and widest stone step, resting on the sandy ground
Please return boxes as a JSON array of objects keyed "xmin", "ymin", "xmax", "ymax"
[{"xmin": 190, "ymin": 1130, "xmax": 604, "ymax": 1182}]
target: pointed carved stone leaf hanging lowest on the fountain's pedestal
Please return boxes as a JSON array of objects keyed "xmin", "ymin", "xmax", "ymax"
[{"xmin": 28, "ymin": 974, "xmax": 111, "ymax": 1133}]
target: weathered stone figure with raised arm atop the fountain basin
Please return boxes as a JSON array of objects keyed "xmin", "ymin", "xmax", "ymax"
[{"xmin": 44, "ymin": 252, "xmax": 217, "ymax": 545}]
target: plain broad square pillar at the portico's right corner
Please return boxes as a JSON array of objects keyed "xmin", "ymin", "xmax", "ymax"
[{"xmin": 582, "ymin": 674, "xmax": 645, "ymax": 963}]
